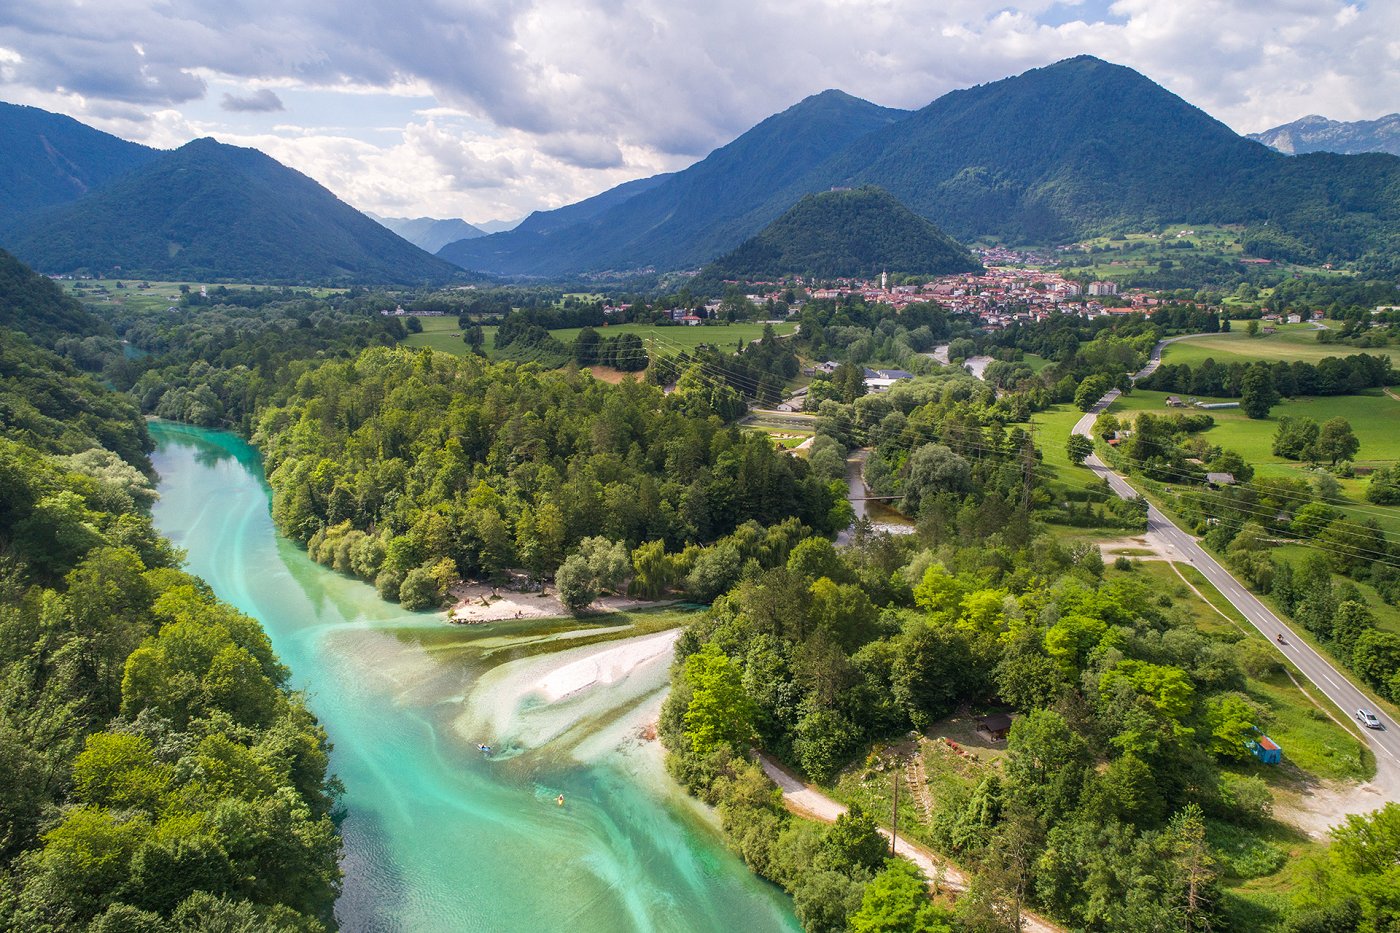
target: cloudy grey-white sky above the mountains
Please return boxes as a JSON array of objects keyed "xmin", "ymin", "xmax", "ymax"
[{"xmin": 0, "ymin": 0, "xmax": 1400, "ymax": 221}]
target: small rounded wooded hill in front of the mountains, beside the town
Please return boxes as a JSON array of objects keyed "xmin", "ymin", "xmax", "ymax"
[{"xmin": 701, "ymin": 186, "xmax": 981, "ymax": 280}]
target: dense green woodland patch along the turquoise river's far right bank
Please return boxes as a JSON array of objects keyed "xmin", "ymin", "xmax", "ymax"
[{"xmin": 253, "ymin": 349, "xmax": 844, "ymax": 608}]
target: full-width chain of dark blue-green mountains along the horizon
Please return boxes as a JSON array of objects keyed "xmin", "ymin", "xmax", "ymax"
[{"xmin": 0, "ymin": 56, "xmax": 1400, "ymax": 283}]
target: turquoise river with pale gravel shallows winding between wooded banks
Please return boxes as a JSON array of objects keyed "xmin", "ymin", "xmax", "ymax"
[{"xmin": 151, "ymin": 423, "xmax": 799, "ymax": 933}]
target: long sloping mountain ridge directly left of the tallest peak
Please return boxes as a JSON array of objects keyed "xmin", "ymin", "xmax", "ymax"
[{"xmin": 438, "ymin": 91, "xmax": 906, "ymax": 276}]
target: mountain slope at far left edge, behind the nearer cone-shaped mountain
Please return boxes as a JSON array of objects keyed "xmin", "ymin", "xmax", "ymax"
[{"xmin": 0, "ymin": 102, "xmax": 160, "ymax": 226}]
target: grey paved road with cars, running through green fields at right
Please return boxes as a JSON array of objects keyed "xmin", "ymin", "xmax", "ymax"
[{"xmin": 1074, "ymin": 335, "xmax": 1400, "ymax": 806}]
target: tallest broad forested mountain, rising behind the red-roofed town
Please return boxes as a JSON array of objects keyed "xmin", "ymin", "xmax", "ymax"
[{"xmin": 756, "ymin": 56, "xmax": 1400, "ymax": 259}]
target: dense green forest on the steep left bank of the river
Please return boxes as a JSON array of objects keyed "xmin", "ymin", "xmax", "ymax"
[{"xmin": 0, "ymin": 264, "xmax": 340, "ymax": 933}]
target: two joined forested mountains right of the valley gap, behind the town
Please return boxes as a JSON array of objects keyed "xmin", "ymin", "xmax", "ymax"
[{"xmin": 438, "ymin": 56, "xmax": 1400, "ymax": 277}]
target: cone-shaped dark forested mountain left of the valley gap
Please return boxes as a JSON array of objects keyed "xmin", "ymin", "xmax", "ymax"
[{"xmin": 4, "ymin": 139, "xmax": 459, "ymax": 284}]
